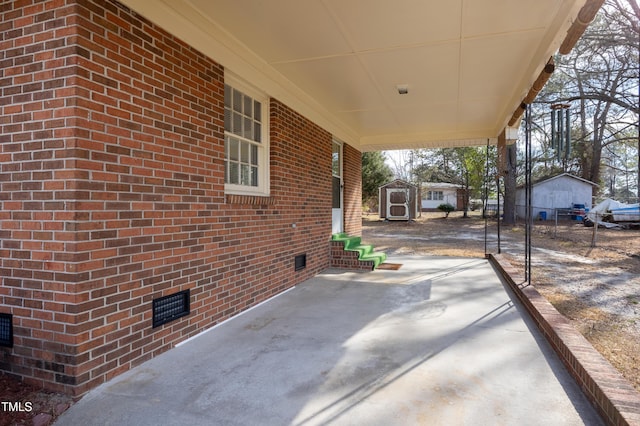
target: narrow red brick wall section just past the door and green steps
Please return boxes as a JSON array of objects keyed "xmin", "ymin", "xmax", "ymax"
[{"xmin": 342, "ymin": 144, "xmax": 362, "ymax": 236}]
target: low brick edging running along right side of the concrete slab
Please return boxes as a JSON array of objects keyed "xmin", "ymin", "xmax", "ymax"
[{"xmin": 487, "ymin": 254, "xmax": 640, "ymax": 426}]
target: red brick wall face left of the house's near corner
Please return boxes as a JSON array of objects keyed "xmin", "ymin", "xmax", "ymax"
[{"xmin": 0, "ymin": 1, "xmax": 93, "ymax": 390}]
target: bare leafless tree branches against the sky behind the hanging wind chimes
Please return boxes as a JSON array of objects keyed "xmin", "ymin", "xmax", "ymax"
[{"xmin": 534, "ymin": 0, "xmax": 640, "ymax": 199}]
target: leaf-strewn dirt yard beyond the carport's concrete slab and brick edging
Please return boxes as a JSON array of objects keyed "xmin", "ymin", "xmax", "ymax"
[{"xmin": 363, "ymin": 212, "xmax": 640, "ymax": 391}]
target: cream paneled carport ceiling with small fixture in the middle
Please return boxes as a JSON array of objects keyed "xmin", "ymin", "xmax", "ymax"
[{"xmin": 117, "ymin": 0, "xmax": 585, "ymax": 151}]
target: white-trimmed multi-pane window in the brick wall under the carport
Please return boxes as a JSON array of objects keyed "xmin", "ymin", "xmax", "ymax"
[{"xmin": 224, "ymin": 77, "xmax": 269, "ymax": 195}]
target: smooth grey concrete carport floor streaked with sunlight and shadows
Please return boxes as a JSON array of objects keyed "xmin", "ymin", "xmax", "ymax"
[{"xmin": 56, "ymin": 256, "xmax": 601, "ymax": 426}]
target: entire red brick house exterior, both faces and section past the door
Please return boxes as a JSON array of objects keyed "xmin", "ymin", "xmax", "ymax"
[{"xmin": 0, "ymin": 0, "xmax": 361, "ymax": 396}]
